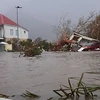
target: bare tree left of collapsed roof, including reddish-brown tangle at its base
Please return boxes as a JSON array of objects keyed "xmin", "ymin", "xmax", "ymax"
[{"xmin": 54, "ymin": 16, "xmax": 72, "ymax": 51}]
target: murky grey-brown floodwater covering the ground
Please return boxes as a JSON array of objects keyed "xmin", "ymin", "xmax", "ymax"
[{"xmin": 0, "ymin": 51, "xmax": 100, "ymax": 100}]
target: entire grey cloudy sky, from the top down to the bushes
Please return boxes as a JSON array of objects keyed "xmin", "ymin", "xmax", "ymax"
[{"xmin": 0, "ymin": 0, "xmax": 100, "ymax": 39}]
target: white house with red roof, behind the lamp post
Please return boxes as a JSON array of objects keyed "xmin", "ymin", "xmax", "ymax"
[{"xmin": 0, "ymin": 14, "xmax": 28, "ymax": 41}]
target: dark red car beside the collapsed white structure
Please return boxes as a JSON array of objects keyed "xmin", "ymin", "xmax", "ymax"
[{"xmin": 78, "ymin": 42, "xmax": 100, "ymax": 51}]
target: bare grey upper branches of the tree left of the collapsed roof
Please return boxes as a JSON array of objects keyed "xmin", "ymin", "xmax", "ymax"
[{"xmin": 54, "ymin": 16, "xmax": 72, "ymax": 41}]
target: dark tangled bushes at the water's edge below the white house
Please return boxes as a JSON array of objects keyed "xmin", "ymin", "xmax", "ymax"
[{"xmin": 8, "ymin": 37, "xmax": 52, "ymax": 57}]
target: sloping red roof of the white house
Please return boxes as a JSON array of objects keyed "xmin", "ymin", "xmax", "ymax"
[{"xmin": 0, "ymin": 14, "xmax": 27, "ymax": 30}]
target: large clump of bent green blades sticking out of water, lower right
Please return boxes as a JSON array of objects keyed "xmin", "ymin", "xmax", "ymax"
[{"xmin": 53, "ymin": 73, "xmax": 100, "ymax": 100}]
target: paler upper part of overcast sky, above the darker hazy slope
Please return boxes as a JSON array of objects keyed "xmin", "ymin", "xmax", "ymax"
[{"xmin": 0, "ymin": 0, "xmax": 100, "ymax": 40}]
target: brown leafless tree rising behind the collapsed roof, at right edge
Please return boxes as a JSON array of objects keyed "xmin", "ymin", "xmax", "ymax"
[{"xmin": 73, "ymin": 12, "xmax": 100, "ymax": 40}]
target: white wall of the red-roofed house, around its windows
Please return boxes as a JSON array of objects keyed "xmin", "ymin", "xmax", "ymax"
[{"xmin": 4, "ymin": 25, "xmax": 28, "ymax": 39}]
